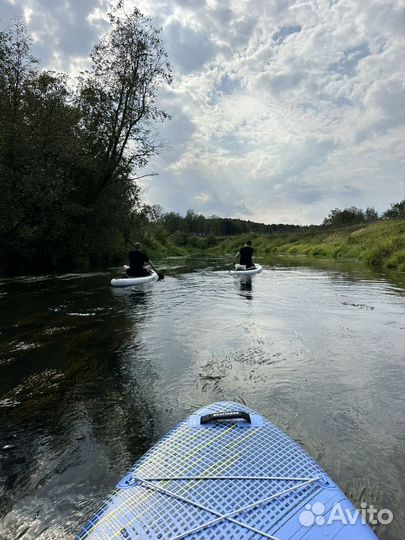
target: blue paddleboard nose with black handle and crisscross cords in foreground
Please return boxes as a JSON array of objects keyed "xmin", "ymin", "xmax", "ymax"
[{"xmin": 77, "ymin": 402, "xmax": 377, "ymax": 540}]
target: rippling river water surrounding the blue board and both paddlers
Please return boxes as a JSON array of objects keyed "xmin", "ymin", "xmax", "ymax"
[{"xmin": 0, "ymin": 258, "xmax": 405, "ymax": 540}]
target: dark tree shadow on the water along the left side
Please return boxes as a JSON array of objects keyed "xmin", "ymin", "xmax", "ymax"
[{"xmin": 0, "ymin": 277, "xmax": 161, "ymax": 539}]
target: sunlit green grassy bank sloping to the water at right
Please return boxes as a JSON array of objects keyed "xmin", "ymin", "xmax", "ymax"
[{"xmin": 209, "ymin": 220, "xmax": 405, "ymax": 271}]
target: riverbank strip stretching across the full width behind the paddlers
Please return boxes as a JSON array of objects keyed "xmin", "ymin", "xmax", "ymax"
[{"xmin": 0, "ymin": 219, "xmax": 405, "ymax": 277}]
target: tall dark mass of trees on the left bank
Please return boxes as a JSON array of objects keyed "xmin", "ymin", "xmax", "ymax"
[{"xmin": 0, "ymin": 4, "xmax": 171, "ymax": 274}]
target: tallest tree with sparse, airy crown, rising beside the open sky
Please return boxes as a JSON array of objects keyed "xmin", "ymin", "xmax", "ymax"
[{"xmin": 79, "ymin": 3, "xmax": 172, "ymax": 197}]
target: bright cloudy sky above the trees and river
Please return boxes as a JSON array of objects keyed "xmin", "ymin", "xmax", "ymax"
[{"xmin": 0, "ymin": 0, "xmax": 405, "ymax": 224}]
